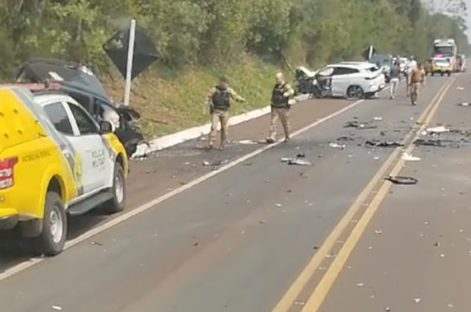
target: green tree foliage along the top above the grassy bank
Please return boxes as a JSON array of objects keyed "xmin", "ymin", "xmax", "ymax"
[{"xmin": 0, "ymin": 0, "xmax": 468, "ymax": 75}]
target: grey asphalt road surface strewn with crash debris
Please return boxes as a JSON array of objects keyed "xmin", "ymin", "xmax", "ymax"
[{"xmin": 0, "ymin": 75, "xmax": 471, "ymax": 312}]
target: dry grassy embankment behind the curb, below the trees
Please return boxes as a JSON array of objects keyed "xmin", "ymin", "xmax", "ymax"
[{"xmin": 103, "ymin": 56, "xmax": 280, "ymax": 138}]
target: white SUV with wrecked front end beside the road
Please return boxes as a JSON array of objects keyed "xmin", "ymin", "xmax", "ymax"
[{"xmin": 316, "ymin": 62, "xmax": 386, "ymax": 98}]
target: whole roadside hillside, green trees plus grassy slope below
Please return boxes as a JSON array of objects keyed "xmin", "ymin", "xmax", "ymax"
[{"xmin": 0, "ymin": 0, "xmax": 468, "ymax": 135}]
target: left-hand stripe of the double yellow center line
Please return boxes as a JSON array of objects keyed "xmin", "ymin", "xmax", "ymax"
[{"xmin": 273, "ymin": 81, "xmax": 451, "ymax": 312}]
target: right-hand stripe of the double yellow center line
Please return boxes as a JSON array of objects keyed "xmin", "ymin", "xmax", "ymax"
[{"xmin": 301, "ymin": 79, "xmax": 454, "ymax": 312}]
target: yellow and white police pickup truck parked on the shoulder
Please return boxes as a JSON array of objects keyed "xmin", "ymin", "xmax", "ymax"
[{"xmin": 0, "ymin": 84, "xmax": 128, "ymax": 256}]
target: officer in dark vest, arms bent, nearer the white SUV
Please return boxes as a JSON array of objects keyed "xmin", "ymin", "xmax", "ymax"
[{"xmin": 267, "ymin": 72, "xmax": 294, "ymax": 144}]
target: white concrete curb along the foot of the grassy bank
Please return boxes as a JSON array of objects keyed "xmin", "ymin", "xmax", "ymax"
[{"xmin": 132, "ymin": 95, "xmax": 308, "ymax": 158}]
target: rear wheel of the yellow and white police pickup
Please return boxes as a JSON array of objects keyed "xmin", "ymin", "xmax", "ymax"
[{"xmin": 34, "ymin": 192, "xmax": 67, "ymax": 256}]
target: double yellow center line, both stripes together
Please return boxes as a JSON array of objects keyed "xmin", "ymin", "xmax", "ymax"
[{"xmin": 273, "ymin": 78, "xmax": 455, "ymax": 312}]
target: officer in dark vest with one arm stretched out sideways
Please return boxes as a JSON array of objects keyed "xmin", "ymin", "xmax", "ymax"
[{"xmin": 208, "ymin": 78, "xmax": 245, "ymax": 149}]
